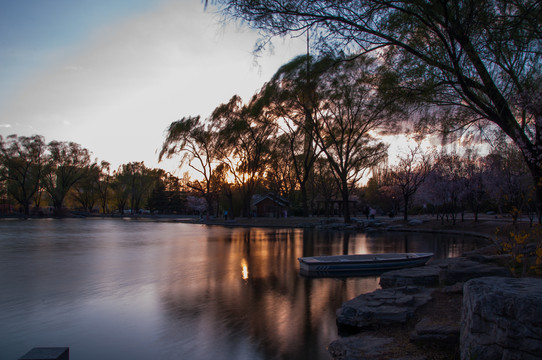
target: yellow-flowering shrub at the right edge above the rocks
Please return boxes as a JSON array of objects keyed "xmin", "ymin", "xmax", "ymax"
[{"xmin": 497, "ymin": 226, "xmax": 542, "ymax": 276}]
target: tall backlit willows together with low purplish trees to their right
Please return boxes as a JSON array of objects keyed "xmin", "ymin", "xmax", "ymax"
[{"xmin": 160, "ymin": 56, "xmax": 536, "ymax": 222}]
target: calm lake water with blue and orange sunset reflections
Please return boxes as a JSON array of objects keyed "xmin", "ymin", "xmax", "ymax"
[{"xmin": 0, "ymin": 219, "xmax": 486, "ymax": 360}]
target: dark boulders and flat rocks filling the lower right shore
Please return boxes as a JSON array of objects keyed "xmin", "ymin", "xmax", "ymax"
[{"xmin": 328, "ymin": 254, "xmax": 542, "ymax": 360}]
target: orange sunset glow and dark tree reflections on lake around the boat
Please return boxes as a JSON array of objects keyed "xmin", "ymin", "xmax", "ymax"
[{"xmin": 157, "ymin": 228, "xmax": 484, "ymax": 359}]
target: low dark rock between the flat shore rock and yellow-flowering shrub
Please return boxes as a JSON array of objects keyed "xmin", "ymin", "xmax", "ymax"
[{"xmin": 440, "ymin": 258, "xmax": 512, "ymax": 285}]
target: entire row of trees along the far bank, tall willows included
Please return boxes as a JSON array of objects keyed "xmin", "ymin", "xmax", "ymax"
[{"xmin": 0, "ymin": 55, "xmax": 540, "ymax": 223}]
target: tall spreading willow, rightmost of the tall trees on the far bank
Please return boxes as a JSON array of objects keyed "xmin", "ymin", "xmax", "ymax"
[{"xmin": 312, "ymin": 57, "xmax": 392, "ymax": 223}]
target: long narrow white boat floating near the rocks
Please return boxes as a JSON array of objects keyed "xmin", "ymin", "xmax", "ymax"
[{"xmin": 297, "ymin": 253, "xmax": 433, "ymax": 276}]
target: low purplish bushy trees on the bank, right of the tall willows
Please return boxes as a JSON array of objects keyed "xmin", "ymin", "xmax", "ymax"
[{"xmin": 372, "ymin": 145, "xmax": 540, "ymax": 225}]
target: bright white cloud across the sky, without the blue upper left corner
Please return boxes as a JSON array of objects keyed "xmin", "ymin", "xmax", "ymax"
[{"xmin": 0, "ymin": 1, "xmax": 304, "ymax": 173}]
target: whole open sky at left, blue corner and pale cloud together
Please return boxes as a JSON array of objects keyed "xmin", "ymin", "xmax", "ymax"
[{"xmin": 0, "ymin": 0, "xmax": 306, "ymax": 175}]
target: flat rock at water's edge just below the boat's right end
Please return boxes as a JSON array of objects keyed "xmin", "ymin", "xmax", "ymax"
[{"xmin": 380, "ymin": 265, "xmax": 442, "ymax": 289}]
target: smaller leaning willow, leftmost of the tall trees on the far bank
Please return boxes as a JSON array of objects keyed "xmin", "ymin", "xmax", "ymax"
[{"xmin": 159, "ymin": 116, "xmax": 219, "ymax": 214}]
